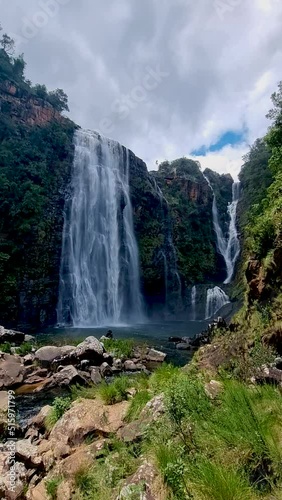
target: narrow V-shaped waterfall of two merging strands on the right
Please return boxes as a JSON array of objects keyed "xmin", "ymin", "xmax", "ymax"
[{"xmin": 203, "ymin": 174, "xmax": 240, "ymax": 285}]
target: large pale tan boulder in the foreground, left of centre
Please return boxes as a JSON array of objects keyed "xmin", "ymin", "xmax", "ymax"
[{"xmin": 46, "ymin": 399, "xmax": 129, "ymax": 451}]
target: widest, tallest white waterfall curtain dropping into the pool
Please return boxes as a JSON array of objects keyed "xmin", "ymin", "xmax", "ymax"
[{"xmin": 58, "ymin": 130, "xmax": 142, "ymax": 327}]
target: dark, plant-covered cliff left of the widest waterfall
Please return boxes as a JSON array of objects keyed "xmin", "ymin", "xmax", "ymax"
[{"xmin": 0, "ymin": 82, "xmax": 75, "ymax": 328}]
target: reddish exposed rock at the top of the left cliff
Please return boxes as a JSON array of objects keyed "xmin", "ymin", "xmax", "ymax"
[{"xmin": 0, "ymin": 82, "xmax": 64, "ymax": 125}]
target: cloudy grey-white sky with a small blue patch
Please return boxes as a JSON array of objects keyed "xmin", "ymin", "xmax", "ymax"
[{"xmin": 0, "ymin": 0, "xmax": 282, "ymax": 177}]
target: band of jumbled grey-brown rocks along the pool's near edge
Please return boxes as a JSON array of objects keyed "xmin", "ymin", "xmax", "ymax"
[{"xmin": 0, "ymin": 337, "xmax": 166, "ymax": 392}]
